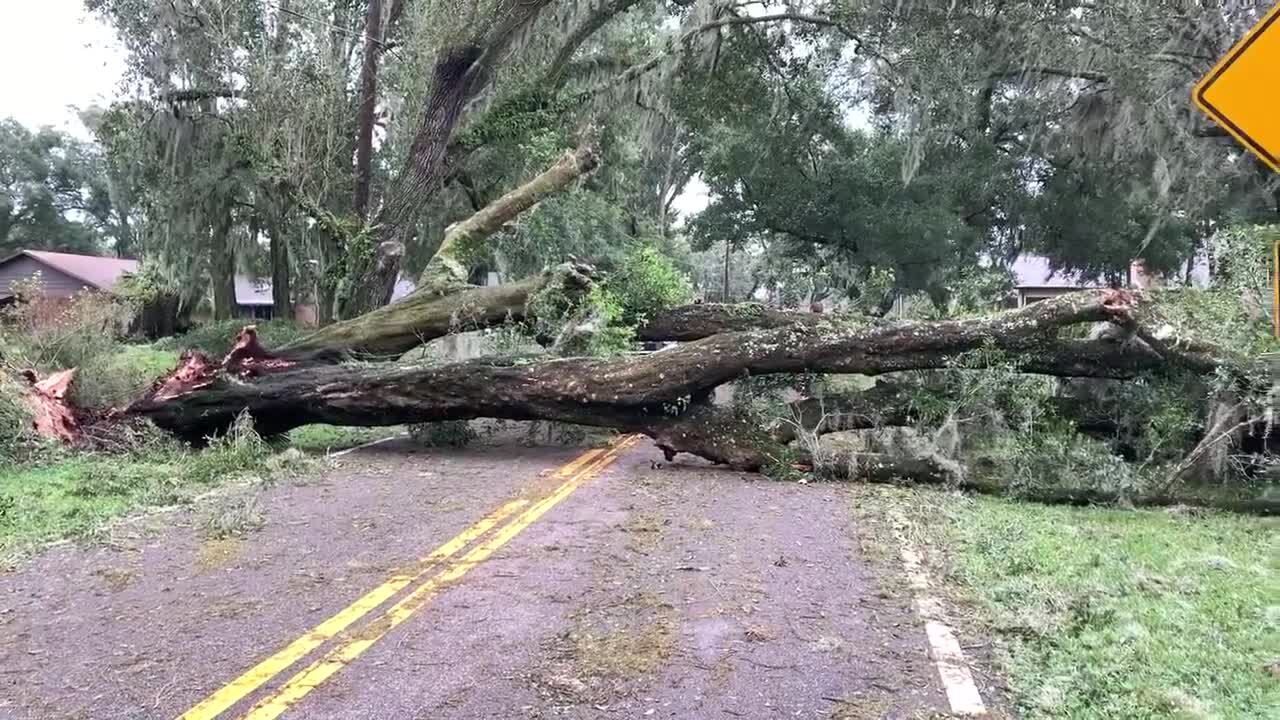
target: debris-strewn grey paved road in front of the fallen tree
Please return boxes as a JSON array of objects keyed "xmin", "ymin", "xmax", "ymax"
[{"xmin": 0, "ymin": 430, "xmax": 988, "ymax": 720}]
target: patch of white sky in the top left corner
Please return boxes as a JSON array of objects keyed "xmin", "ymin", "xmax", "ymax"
[{"xmin": 0, "ymin": 0, "xmax": 124, "ymax": 137}]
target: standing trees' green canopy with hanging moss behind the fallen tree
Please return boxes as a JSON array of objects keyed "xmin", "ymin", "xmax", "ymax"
[{"xmin": 0, "ymin": 0, "xmax": 1280, "ymax": 312}]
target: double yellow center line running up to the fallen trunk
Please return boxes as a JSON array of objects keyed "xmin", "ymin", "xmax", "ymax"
[{"xmin": 179, "ymin": 436, "xmax": 640, "ymax": 720}]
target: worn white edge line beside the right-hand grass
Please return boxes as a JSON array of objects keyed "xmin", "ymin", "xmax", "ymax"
[{"xmin": 893, "ymin": 516, "xmax": 987, "ymax": 715}]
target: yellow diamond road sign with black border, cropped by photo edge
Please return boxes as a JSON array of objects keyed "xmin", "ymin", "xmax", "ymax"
[{"xmin": 1192, "ymin": 5, "xmax": 1280, "ymax": 172}]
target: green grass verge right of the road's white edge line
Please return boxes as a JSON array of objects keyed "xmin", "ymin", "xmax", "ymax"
[{"xmin": 869, "ymin": 489, "xmax": 1280, "ymax": 719}]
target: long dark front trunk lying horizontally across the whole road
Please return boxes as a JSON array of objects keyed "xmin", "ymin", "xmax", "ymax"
[{"xmin": 129, "ymin": 288, "xmax": 1222, "ymax": 440}]
